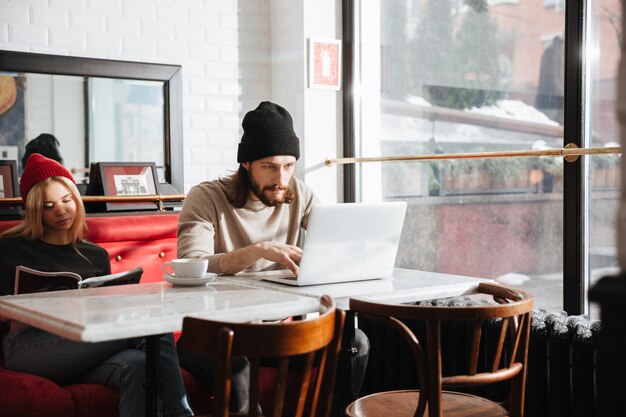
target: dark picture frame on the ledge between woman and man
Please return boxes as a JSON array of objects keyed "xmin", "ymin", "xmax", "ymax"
[{"xmin": 94, "ymin": 162, "xmax": 158, "ymax": 211}]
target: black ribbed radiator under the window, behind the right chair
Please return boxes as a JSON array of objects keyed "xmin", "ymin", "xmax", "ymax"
[{"xmin": 358, "ymin": 297, "xmax": 600, "ymax": 417}]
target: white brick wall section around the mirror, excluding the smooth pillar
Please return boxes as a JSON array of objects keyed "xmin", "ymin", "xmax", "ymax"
[{"xmin": 0, "ymin": 0, "xmax": 271, "ymax": 192}]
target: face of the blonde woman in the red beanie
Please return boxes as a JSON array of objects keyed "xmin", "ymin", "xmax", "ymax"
[{"xmin": 42, "ymin": 181, "xmax": 76, "ymax": 233}]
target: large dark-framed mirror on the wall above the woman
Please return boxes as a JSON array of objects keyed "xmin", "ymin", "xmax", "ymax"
[{"xmin": 0, "ymin": 51, "xmax": 183, "ymax": 194}]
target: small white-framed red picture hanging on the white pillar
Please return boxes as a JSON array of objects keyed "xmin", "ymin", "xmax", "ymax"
[{"xmin": 309, "ymin": 39, "xmax": 341, "ymax": 90}]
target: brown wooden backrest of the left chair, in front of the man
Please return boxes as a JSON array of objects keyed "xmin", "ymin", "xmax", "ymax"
[{"xmin": 179, "ymin": 296, "xmax": 345, "ymax": 417}]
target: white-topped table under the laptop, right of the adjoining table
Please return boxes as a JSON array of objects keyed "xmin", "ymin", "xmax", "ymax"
[{"xmin": 222, "ymin": 268, "xmax": 494, "ymax": 415}]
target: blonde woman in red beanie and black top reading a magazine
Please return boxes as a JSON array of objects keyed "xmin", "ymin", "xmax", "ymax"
[{"xmin": 0, "ymin": 153, "xmax": 193, "ymax": 417}]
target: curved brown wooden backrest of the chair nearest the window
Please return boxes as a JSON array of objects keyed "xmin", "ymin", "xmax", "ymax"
[{"xmin": 350, "ymin": 283, "xmax": 533, "ymax": 417}]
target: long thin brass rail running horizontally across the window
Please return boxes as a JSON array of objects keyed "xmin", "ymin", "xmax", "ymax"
[{"xmin": 324, "ymin": 143, "xmax": 622, "ymax": 167}]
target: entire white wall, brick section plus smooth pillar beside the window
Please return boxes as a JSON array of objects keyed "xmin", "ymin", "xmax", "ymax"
[{"xmin": 0, "ymin": 0, "xmax": 341, "ymax": 197}]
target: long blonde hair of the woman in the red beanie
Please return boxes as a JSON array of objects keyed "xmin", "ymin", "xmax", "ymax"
[{"xmin": 1, "ymin": 177, "xmax": 87, "ymax": 253}]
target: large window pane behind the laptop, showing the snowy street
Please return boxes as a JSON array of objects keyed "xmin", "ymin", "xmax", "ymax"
[{"xmin": 354, "ymin": 0, "xmax": 565, "ymax": 309}]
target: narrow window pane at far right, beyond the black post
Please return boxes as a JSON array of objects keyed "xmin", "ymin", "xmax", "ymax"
[{"xmin": 585, "ymin": 0, "xmax": 622, "ymax": 316}]
